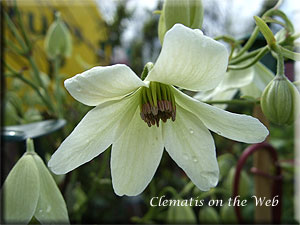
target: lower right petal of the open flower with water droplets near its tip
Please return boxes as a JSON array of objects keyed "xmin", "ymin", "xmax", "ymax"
[{"xmin": 163, "ymin": 106, "xmax": 219, "ymax": 191}]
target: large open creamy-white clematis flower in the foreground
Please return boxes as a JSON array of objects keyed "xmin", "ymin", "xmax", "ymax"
[{"xmin": 48, "ymin": 24, "xmax": 268, "ymax": 196}]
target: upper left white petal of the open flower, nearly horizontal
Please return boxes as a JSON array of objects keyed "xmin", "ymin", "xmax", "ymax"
[{"xmin": 65, "ymin": 64, "xmax": 147, "ymax": 106}]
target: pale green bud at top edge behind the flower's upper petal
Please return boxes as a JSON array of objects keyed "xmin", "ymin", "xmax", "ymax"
[{"xmin": 158, "ymin": 0, "xmax": 204, "ymax": 43}]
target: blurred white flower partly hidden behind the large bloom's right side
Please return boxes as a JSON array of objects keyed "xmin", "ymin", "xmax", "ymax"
[{"xmin": 194, "ymin": 62, "xmax": 274, "ymax": 108}]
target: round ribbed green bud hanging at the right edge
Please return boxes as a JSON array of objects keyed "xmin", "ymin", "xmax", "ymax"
[{"xmin": 261, "ymin": 75, "xmax": 300, "ymax": 125}]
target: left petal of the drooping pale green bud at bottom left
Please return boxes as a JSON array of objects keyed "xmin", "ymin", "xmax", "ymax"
[{"xmin": 3, "ymin": 154, "xmax": 40, "ymax": 224}]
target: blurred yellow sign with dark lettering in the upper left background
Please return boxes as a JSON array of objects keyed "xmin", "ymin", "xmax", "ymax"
[{"xmin": 4, "ymin": 0, "xmax": 111, "ymax": 78}]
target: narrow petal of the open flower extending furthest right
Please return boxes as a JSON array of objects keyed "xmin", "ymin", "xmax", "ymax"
[{"xmin": 173, "ymin": 88, "xmax": 269, "ymax": 143}]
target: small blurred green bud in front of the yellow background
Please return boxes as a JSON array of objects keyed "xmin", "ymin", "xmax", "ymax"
[{"xmin": 45, "ymin": 13, "xmax": 72, "ymax": 59}]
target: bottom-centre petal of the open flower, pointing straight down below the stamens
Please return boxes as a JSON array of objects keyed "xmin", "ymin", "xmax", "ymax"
[{"xmin": 111, "ymin": 109, "xmax": 164, "ymax": 196}]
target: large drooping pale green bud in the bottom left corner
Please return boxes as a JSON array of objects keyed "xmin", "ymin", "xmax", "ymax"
[{"xmin": 3, "ymin": 139, "xmax": 69, "ymax": 224}]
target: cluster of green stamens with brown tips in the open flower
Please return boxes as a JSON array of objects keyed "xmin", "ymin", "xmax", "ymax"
[{"xmin": 140, "ymin": 81, "xmax": 176, "ymax": 127}]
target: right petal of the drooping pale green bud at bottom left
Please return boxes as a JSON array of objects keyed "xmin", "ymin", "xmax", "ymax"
[{"xmin": 33, "ymin": 154, "xmax": 69, "ymax": 224}]
